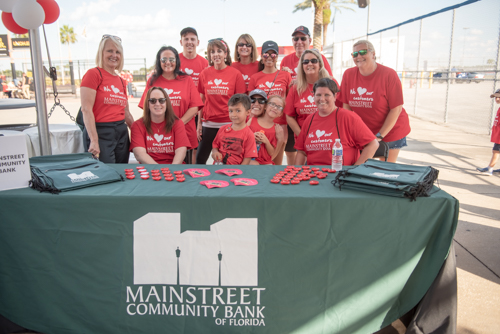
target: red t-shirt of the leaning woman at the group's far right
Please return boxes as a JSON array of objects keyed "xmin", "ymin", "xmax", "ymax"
[{"xmin": 340, "ymin": 63, "xmax": 411, "ymax": 142}]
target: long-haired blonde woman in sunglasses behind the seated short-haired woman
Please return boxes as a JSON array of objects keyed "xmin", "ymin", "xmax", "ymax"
[{"xmin": 285, "ymin": 49, "xmax": 342, "ymax": 165}]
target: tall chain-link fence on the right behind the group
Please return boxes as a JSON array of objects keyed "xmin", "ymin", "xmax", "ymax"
[{"xmin": 325, "ymin": 0, "xmax": 500, "ymax": 134}]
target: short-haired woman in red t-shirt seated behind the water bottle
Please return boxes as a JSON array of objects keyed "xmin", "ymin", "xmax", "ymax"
[{"xmin": 295, "ymin": 78, "xmax": 378, "ymax": 166}]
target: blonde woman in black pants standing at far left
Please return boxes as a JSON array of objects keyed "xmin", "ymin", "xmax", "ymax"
[{"xmin": 80, "ymin": 35, "xmax": 134, "ymax": 163}]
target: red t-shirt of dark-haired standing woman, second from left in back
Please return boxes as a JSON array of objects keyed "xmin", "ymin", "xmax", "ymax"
[{"xmin": 139, "ymin": 75, "xmax": 203, "ymax": 149}]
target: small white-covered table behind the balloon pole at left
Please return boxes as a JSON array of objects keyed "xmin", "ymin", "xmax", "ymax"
[{"xmin": 23, "ymin": 124, "xmax": 83, "ymax": 156}]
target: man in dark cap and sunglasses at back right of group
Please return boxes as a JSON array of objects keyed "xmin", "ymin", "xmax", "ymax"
[{"xmin": 280, "ymin": 26, "xmax": 333, "ymax": 80}]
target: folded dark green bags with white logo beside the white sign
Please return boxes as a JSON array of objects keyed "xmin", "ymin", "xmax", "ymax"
[{"xmin": 29, "ymin": 153, "xmax": 124, "ymax": 194}]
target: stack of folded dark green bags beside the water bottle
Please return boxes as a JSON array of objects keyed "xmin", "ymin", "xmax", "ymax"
[{"xmin": 332, "ymin": 159, "xmax": 439, "ymax": 201}]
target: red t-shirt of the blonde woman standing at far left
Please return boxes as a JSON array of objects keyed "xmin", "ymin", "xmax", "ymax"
[{"xmin": 81, "ymin": 67, "xmax": 127, "ymax": 123}]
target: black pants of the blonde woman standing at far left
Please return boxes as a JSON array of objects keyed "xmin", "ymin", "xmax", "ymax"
[{"xmin": 83, "ymin": 121, "xmax": 130, "ymax": 164}]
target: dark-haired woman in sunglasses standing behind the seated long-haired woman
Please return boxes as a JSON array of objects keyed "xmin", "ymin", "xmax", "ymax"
[{"xmin": 139, "ymin": 46, "xmax": 203, "ymax": 160}]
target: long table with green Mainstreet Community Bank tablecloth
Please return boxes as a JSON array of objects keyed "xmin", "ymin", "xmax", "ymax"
[{"xmin": 0, "ymin": 165, "xmax": 459, "ymax": 333}]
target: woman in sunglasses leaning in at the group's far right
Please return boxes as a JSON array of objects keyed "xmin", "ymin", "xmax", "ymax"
[{"xmin": 340, "ymin": 40, "xmax": 411, "ymax": 162}]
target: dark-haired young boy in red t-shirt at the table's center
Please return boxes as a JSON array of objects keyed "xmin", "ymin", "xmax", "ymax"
[{"xmin": 212, "ymin": 94, "xmax": 258, "ymax": 165}]
